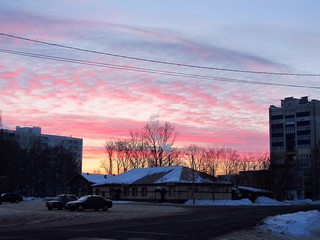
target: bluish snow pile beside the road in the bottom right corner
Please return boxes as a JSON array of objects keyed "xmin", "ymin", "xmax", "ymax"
[{"xmin": 258, "ymin": 210, "xmax": 320, "ymax": 237}]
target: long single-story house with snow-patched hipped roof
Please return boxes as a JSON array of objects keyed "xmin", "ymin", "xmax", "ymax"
[{"xmin": 92, "ymin": 166, "xmax": 232, "ymax": 203}]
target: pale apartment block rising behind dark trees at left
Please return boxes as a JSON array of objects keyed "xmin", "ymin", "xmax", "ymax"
[{"xmin": 4, "ymin": 126, "xmax": 83, "ymax": 172}]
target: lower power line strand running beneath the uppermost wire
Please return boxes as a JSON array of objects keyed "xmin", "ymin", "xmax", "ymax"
[{"xmin": 0, "ymin": 48, "xmax": 320, "ymax": 89}]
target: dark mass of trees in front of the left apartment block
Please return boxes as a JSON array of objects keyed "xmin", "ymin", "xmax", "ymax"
[{"xmin": 0, "ymin": 128, "xmax": 78, "ymax": 197}]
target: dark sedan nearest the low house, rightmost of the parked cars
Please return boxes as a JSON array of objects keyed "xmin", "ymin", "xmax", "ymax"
[{"xmin": 66, "ymin": 195, "xmax": 112, "ymax": 211}]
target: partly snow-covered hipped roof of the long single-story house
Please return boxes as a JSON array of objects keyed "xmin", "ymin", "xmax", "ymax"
[{"xmin": 94, "ymin": 166, "xmax": 230, "ymax": 186}]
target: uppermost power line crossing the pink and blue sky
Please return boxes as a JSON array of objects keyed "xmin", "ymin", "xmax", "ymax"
[{"xmin": 0, "ymin": 32, "xmax": 320, "ymax": 77}]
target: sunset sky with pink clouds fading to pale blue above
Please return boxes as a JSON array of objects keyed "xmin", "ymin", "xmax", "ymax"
[{"xmin": 0, "ymin": 0, "xmax": 320, "ymax": 172}]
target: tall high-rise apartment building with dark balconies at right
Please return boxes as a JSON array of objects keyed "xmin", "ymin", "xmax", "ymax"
[{"xmin": 269, "ymin": 97, "xmax": 320, "ymax": 199}]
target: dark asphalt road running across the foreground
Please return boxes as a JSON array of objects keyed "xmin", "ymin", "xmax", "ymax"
[{"xmin": 0, "ymin": 206, "xmax": 320, "ymax": 240}]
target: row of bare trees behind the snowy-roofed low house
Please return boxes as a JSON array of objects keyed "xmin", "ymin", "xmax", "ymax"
[{"xmin": 100, "ymin": 116, "xmax": 270, "ymax": 176}]
